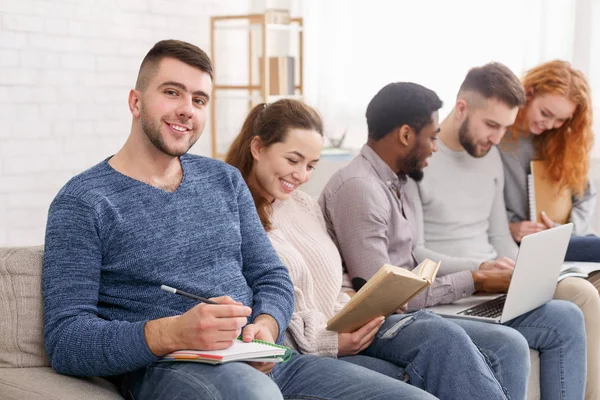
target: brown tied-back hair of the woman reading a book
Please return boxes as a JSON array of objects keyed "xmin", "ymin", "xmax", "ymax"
[{"xmin": 225, "ymin": 99, "xmax": 323, "ymax": 231}]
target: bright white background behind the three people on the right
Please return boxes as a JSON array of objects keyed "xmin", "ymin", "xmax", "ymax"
[{"xmin": 301, "ymin": 0, "xmax": 600, "ymax": 157}]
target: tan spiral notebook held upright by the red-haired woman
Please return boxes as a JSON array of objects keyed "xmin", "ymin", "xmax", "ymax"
[{"xmin": 527, "ymin": 161, "xmax": 573, "ymax": 224}]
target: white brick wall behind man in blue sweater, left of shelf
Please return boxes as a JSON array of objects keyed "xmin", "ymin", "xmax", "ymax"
[{"xmin": 0, "ymin": 0, "xmax": 249, "ymax": 245}]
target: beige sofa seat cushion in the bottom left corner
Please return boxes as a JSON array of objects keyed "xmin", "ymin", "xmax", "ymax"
[{"xmin": 0, "ymin": 367, "xmax": 123, "ymax": 400}]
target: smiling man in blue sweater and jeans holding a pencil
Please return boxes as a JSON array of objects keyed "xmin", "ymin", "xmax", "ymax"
[{"xmin": 43, "ymin": 40, "xmax": 432, "ymax": 399}]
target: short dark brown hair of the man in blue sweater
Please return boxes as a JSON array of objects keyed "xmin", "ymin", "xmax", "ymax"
[{"xmin": 135, "ymin": 39, "xmax": 213, "ymax": 91}]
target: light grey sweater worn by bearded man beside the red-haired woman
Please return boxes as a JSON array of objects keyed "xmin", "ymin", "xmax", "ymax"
[{"xmin": 406, "ymin": 140, "xmax": 518, "ymax": 274}]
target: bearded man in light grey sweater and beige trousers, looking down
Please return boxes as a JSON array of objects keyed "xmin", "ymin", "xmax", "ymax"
[{"xmin": 407, "ymin": 64, "xmax": 600, "ymax": 399}]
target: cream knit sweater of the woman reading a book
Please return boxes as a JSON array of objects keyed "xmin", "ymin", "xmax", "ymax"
[{"xmin": 268, "ymin": 190, "xmax": 350, "ymax": 357}]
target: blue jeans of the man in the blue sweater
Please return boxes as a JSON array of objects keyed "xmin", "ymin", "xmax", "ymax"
[{"xmin": 121, "ymin": 353, "xmax": 435, "ymax": 400}]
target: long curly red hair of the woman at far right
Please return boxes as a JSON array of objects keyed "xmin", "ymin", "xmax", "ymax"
[{"xmin": 514, "ymin": 60, "xmax": 594, "ymax": 195}]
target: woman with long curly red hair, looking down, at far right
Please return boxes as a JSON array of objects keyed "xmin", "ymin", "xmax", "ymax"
[{"xmin": 498, "ymin": 60, "xmax": 600, "ymax": 399}]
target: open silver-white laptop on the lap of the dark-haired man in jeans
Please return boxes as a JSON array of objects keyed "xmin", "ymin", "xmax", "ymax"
[{"xmin": 428, "ymin": 223, "xmax": 573, "ymax": 324}]
